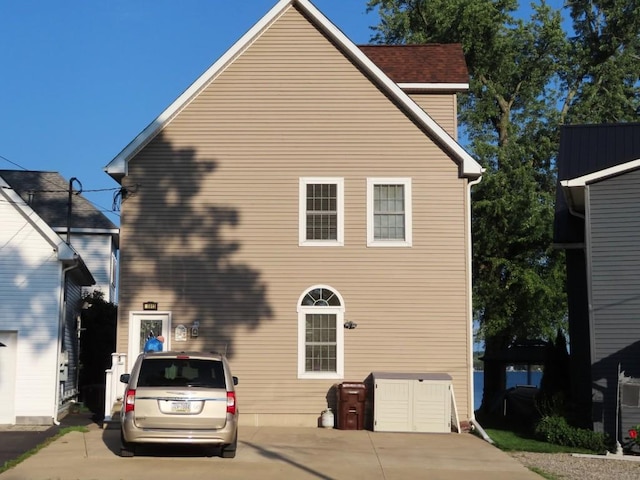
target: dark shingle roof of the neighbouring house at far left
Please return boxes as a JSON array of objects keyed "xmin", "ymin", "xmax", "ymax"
[{"xmin": 0, "ymin": 170, "xmax": 118, "ymax": 231}]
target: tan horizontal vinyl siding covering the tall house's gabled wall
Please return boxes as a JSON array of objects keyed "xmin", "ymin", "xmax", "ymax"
[{"xmin": 118, "ymin": 4, "xmax": 470, "ymax": 424}]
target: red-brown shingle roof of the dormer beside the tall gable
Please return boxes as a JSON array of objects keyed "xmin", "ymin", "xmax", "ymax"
[{"xmin": 359, "ymin": 43, "xmax": 469, "ymax": 84}]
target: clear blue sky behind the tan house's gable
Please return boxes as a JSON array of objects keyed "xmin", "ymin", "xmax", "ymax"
[{"xmin": 0, "ymin": 0, "xmax": 559, "ymax": 225}]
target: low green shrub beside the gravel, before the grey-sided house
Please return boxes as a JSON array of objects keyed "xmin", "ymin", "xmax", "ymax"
[{"xmin": 535, "ymin": 415, "xmax": 607, "ymax": 453}]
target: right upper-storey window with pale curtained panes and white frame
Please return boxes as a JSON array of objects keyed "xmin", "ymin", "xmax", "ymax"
[{"xmin": 367, "ymin": 178, "xmax": 412, "ymax": 247}]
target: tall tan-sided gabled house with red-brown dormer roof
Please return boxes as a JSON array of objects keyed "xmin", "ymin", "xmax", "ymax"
[{"xmin": 105, "ymin": 0, "xmax": 482, "ymax": 426}]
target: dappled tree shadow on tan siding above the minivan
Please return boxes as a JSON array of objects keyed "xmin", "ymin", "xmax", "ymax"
[{"xmin": 120, "ymin": 135, "xmax": 272, "ymax": 357}]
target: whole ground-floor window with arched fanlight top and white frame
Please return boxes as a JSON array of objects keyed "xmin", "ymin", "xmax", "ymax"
[{"xmin": 298, "ymin": 285, "xmax": 344, "ymax": 378}]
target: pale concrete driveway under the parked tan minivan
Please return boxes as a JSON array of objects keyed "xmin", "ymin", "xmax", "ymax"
[{"xmin": 0, "ymin": 424, "xmax": 541, "ymax": 480}]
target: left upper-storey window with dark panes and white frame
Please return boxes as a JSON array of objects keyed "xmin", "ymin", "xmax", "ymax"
[{"xmin": 299, "ymin": 177, "xmax": 344, "ymax": 246}]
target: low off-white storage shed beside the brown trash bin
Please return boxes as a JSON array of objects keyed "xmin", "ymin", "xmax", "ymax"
[{"xmin": 371, "ymin": 372, "xmax": 452, "ymax": 433}]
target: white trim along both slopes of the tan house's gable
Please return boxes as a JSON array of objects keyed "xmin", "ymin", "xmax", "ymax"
[{"xmin": 104, "ymin": 0, "xmax": 484, "ymax": 178}]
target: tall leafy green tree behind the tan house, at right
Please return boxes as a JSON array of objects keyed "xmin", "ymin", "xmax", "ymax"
[{"xmin": 368, "ymin": 0, "xmax": 640, "ymax": 406}]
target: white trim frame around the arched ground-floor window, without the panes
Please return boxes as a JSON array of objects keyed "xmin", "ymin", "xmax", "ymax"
[{"xmin": 298, "ymin": 285, "xmax": 344, "ymax": 379}]
